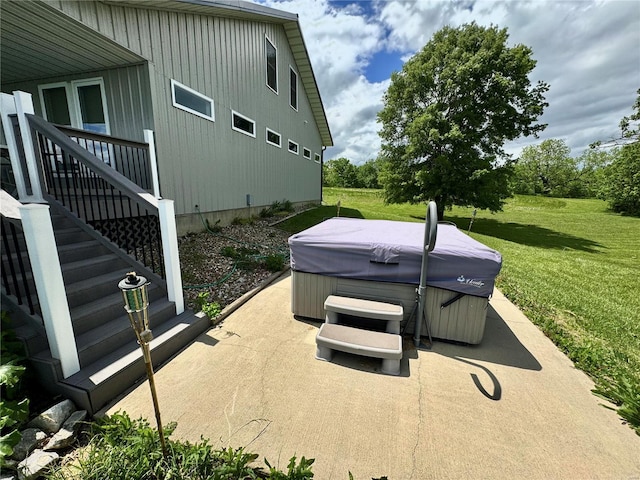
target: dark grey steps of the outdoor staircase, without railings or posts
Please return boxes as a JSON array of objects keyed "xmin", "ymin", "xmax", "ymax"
[{"xmin": 3, "ymin": 200, "xmax": 210, "ymax": 413}]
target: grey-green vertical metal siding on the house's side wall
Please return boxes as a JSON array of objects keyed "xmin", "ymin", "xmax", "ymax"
[{"xmin": 48, "ymin": 2, "xmax": 322, "ymax": 214}]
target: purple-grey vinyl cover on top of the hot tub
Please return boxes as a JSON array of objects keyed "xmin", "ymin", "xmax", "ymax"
[{"xmin": 289, "ymin": 218, "xmax": 502, "ymax": 298}]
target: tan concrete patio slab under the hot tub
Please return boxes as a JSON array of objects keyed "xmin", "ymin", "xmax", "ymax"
[{"xmin": 106, "ymin": 274, "xmax": 640, "ymax": 480}]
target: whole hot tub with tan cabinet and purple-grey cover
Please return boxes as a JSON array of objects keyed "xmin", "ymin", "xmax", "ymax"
[{"xmin": 289, "ymin": 218, "xmax": 502, "ymax": 344}]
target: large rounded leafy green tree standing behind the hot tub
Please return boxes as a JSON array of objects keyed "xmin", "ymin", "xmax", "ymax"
[{"xmin": 378, "ymin": 23, "xmax": 549, "ymax": 217}]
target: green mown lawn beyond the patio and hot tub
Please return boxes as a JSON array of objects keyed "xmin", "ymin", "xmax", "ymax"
[{"xmin": 280, "ymin": 188, "xmax": 640, "ymax": 434}]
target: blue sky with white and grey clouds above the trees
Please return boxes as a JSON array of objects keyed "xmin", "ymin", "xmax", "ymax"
[{"xmin": 260, "ymin": 0, "xmax": 640, "ymax": 165}]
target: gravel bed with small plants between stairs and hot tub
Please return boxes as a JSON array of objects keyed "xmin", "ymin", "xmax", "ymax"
[{"xmin": 178, "ymin": 218, "xmax": 290, "ymax": 309}]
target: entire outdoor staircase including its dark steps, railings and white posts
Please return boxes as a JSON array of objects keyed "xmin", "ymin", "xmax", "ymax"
[{"xmin": 0, "ymin": 99, "xmax": 210, "ymax": 414}]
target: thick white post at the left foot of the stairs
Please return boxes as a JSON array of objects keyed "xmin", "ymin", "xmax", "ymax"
[{"xmin": 19, "ymin": 204, "xmax": 80, "ymax": 378}]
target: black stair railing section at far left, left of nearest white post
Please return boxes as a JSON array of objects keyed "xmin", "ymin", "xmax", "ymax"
[{"xmin": 0, "ymin": 215, "xmax": 42, "ymax": 316}]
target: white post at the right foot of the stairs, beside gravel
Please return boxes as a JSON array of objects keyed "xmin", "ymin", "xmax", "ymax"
[{"xmin": 158, "ymin": 199, "xmax": 184, "ymax": 315}]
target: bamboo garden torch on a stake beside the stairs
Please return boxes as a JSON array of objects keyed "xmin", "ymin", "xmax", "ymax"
[{"xmin": 118, "ymin": 272, "xmax": 167, "ymax": 458}]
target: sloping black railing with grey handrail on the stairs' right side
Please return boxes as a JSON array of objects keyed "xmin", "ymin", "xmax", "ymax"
[{"xmin": 27, "ymin": 115, "xmax": 165, "ymax": 278}]
